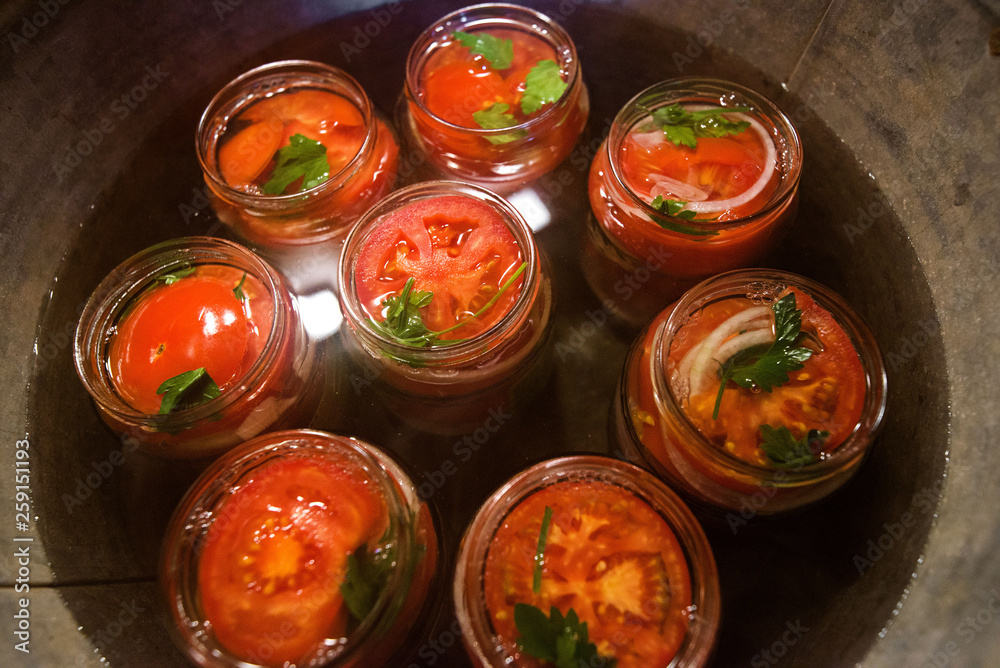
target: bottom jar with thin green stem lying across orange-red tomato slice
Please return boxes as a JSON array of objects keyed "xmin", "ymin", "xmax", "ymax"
[{"xmin": 453, "ymin": 455, "xmax": 720, "ymax": 668}]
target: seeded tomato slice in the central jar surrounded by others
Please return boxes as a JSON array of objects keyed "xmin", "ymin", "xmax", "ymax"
[{"xmin": 355, "ymin": 195, "xmax": 524, "ymax": 339}]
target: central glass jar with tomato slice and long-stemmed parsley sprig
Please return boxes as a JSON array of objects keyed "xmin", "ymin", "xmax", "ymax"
[{"xmin": 340, "ymin": 181, "xmax": 552, "ymax": 431}]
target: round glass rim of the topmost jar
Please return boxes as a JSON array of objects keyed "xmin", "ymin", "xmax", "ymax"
[{"xmin": 404, "ymin": 3, "xmax": 581, "ymax": 138}]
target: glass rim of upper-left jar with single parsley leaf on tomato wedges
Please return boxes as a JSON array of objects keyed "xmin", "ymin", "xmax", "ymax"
[{"xmin": 195, "ymin": 60, "xmax": 377, "ymax": 211}]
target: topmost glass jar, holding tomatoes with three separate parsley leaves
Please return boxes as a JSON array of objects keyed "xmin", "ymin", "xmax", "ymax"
[{"xmin": 396, "ymin": 4, "xmax": 590, "ymax": 192}]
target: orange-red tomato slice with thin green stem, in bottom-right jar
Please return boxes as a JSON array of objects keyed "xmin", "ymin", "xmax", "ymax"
[{"xmin": 484, "ymin": 482, "xmax": 691, "ymax": 668}]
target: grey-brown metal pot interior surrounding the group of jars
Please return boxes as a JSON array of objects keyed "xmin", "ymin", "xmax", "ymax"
[{"xmin": 0, "ymin": 0, "xmax": 1000, "ymax": 666}]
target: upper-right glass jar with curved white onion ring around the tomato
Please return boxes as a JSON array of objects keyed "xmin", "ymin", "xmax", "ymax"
[{"xmin": 583, "ymin": 78, "xmax": 802, "ymax": 326}]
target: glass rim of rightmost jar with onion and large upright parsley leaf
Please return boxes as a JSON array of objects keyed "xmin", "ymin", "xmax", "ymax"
[{"xmin": 643, "ymin": 269, "xmax": 887, "ymax": 487}]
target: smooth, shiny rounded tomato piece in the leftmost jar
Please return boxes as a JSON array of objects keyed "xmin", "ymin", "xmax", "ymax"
[{"xmin": 109, "ymin": 265, "xmax": 273, "ymax": 414}]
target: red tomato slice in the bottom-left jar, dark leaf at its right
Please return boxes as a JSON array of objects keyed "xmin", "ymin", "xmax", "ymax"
[{"xmin": 198, "ymin": 457, "xmax": 387, "ymax": 666}]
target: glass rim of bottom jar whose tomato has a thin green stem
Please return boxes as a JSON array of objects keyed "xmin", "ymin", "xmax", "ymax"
[{"xmin": 452, "ymin": 455, "xmax": 721, "ymax": 667}]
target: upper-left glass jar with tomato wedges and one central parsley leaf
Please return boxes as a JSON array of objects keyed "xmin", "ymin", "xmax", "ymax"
[{"xmin": 197, "ymin": 60, "xmax": 399, "ymax": 288}]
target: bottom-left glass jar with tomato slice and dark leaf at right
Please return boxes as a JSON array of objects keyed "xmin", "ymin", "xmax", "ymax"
[{"xmin": 161, "ymin": 430, "xmax": 438, "ymax": 668}]
